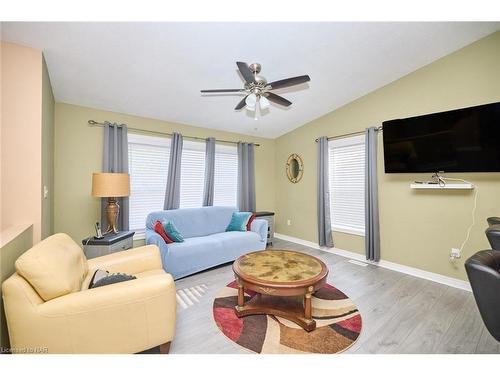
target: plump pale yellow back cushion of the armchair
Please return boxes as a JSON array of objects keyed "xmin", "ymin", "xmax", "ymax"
[{"xmin": 15, "ymin": 233, "xmax": 88, "ymax": 301}]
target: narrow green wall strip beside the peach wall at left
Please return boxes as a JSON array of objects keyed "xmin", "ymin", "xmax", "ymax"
[{"xmin": 41, "ymin": 59, "xmax": 55, "ymax": 239}]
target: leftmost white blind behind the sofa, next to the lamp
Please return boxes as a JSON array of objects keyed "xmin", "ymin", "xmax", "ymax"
[{"xmin": 128, "ymin": 133, "xmax": 170, "ymax": 235}]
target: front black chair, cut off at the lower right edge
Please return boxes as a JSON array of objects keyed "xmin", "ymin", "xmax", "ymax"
[{"xmin": 465, "ymin": 250, "xmax": 500, "ymax": 342}]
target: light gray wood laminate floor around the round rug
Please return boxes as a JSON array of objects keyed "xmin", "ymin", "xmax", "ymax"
[{"xmin": 170, "ymin": 239, "xmax": 500, "ymax": 354}]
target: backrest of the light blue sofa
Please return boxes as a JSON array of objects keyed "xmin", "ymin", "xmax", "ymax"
[{"xmin": 146, "ymin": 206, "xmax": 236, "ymax": 239}]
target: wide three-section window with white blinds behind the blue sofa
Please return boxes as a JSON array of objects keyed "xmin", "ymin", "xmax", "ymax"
[{"xmin": 128, "ymin": 133, "xmax": 238, "ymax": 238}]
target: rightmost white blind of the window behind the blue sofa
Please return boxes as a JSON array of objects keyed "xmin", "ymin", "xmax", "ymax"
[{"xmin": 214, "ymin": 144, "xmax": 238, "ymax": 207}]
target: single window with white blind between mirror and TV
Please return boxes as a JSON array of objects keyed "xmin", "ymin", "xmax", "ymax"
[{"xmin": 329, "ymin": 135, "xmax": 365, "ymax": 235}]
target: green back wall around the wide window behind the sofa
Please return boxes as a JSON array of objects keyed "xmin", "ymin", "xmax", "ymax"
[{"xmin": 54, "ymin": 103, "xmax": 275, "ymax": 245}]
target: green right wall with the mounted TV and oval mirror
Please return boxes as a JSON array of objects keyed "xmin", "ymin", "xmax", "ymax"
[{"xmin": 276, "ymin": 32, "xmax": 500, "ymax": 279}]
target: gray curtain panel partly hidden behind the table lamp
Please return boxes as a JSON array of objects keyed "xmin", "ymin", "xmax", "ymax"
[{"xmin": 101, "ymin": 121, "xmax": 129, "ymax": 231}]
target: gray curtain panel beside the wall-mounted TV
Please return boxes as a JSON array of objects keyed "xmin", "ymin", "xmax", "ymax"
[{"xmin": 365, "ymin": 127, "xmax": 380, "ymax": 261}]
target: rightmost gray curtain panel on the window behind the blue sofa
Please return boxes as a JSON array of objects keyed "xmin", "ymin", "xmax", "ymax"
[{"xmin": 237, "ymin": 142, "xmax": 255, "ymax": 212}]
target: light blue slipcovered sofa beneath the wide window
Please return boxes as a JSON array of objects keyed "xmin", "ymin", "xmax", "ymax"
[{"xmin": 146, "ymin": 206, "xmax": 267, "ymax": 279}]
